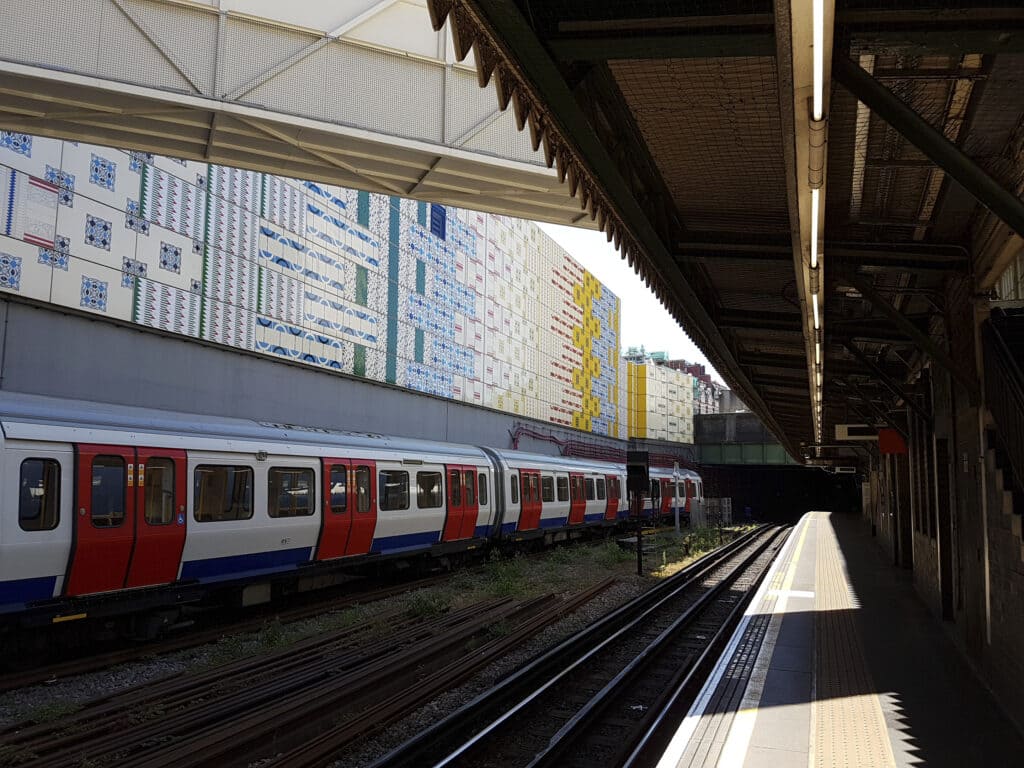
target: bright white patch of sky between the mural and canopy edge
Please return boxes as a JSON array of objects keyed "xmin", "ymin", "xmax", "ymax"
[{"xmin": 538, "ymin": 223, "xmax": 722, "ymax": 381}]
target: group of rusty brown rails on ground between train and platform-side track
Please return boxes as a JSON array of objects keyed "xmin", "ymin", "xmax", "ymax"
[{"xmin": 0, "ymin": 580, "xmax": 612, "ymax": 768}]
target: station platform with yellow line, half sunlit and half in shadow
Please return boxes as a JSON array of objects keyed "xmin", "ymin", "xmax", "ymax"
[{"xmin": 658, "ymin": 512, "xmax": 1024, "ymax": 768}]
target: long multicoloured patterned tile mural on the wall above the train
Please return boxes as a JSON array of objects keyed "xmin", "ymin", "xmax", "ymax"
[{"xmin": 0, "ymin": 132, "xmax": 628, "ymax": 438}]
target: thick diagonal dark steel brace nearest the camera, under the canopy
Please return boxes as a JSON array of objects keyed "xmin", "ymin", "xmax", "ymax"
[{"xmin": 833, "ymin": 54, "xmax": 1024, "ymax": 236}]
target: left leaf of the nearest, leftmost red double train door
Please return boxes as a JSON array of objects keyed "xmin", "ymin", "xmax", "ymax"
[{"xmin": 65, "ymin": 445, "xmax": 135, "ymax": 595}]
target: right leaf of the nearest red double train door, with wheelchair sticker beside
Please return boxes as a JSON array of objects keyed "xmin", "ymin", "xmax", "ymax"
[{"xmin": 125, "ymin": 449, "xmax": 187, "ymax": 587}]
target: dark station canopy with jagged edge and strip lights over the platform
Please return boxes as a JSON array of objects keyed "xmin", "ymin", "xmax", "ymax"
[{"xmin": 428, "ymin": 0, "xmax": 1024, "ymax": 457}]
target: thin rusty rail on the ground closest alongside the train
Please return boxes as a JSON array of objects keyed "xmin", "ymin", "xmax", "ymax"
[{"xmin": 0, "ymin": 574, "xmax": 450, "ymax": 692}]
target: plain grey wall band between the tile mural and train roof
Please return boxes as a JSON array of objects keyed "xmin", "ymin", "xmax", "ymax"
[{"xmin": 0, "ymin": 301, "xmax": 625, "ymax": 453}]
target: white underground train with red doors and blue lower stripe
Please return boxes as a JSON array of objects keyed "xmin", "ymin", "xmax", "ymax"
[{"xmin": 0, "ymin": 393, "xmax": 703, "ymax": 627}]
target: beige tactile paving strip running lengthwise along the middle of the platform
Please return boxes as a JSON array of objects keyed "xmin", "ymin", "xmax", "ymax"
[{"xmin": 810, "ymin": 515, "xmax": 896, "ymax": 768}]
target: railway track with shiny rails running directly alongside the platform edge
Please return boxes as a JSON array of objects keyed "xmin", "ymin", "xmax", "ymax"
[{"xmin": 374, "ymin": 528, "xmax": 785, "ymax": 768}]
